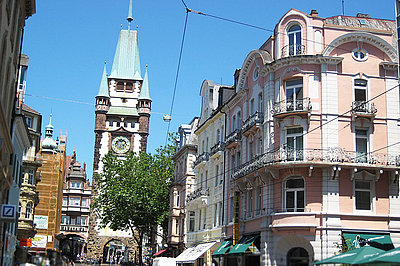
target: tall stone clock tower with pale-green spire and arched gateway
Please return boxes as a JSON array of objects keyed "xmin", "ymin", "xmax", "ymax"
[{"xmin": 87, "ymin": 0, "xmax": 151, "ymax": 263}]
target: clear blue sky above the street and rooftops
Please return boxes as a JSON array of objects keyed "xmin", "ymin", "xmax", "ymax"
[{"xmin": 23, "ymin": 0, "xmax": 395, "ymax": 179}]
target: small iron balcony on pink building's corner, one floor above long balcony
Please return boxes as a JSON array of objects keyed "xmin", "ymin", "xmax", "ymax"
[{"xmin": 272, "ymin": 97, "xmax": 312, "ymax": 118}]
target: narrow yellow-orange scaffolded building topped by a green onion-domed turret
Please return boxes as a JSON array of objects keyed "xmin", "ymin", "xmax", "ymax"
[{"xmin": 32, "ymin": 119, "xmax": 67, "ymax": 249}]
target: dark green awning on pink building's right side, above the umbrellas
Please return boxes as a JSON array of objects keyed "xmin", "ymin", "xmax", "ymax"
[{"xmin": 343, "ymin": 233, "xmax": 394, "ymax": 250}]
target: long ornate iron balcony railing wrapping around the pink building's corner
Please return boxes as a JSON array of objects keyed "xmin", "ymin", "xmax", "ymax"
[{"xmin": 232, "ymin": 147, "xmax": 400, "ymax": 179}]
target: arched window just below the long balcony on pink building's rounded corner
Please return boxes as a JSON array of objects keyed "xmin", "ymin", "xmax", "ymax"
[{"xmin": 284, "ymin": 177, "xmax": 304, "ymax": 212}]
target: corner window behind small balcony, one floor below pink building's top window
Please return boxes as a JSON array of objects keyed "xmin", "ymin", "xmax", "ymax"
[{"xmin": 285, "ymin": 79, "xmax": 303, "ymax": 112}]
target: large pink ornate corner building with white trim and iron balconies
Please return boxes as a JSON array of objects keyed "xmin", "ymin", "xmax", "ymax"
[{"xmin": 209, "ymin": 9, "xmax": 400, "ymax": 265}]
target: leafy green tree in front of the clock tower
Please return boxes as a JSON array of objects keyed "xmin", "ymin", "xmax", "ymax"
[{"xmin": 93, "ymin": 142, "xmax": 174, "ymax": 265}]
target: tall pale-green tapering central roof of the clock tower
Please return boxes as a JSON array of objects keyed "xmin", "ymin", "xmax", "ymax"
[{"xmin": 110, "ymin": 30, "xmax": 142, "ymax": 80}]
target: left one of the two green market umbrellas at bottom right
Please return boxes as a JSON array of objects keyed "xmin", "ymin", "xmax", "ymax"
[{"xmin": 314, "ymin": 246, "xmax": 385, "ymax": 265}]
